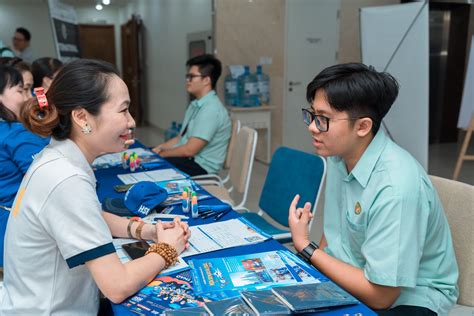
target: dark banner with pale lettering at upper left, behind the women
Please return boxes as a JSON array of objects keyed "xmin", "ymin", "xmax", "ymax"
[{"xmin": 48, "ymin": 0, "xmax": 81, "ymax": 63}]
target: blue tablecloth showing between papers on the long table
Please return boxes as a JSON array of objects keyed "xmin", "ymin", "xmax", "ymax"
[{"xmin": 95, "ymin": 144, "xmax": 376, "ymax": 316}]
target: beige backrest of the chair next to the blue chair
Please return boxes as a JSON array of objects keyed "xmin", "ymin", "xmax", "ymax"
[{"xmin": 229, "ymin": 126, "xmax": 257, "ymax": 199}]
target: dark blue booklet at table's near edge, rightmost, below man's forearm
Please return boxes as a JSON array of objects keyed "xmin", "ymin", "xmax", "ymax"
[{"xmin": 271, "ymin": 282, "xmax": 359, "ymax": 313}]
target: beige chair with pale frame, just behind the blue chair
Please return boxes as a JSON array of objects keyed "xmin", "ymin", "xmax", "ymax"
[{"xmin": 202, "ymin": 126, "xmax": 258, "ymax": 209}]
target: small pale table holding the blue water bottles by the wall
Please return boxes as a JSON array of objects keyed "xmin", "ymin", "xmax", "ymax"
[{"xmin": 226, "ymin": 105, "xmax": 275, "ymax": 163}]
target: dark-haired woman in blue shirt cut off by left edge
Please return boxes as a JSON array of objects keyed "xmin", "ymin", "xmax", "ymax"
[{"xmin": 0, "ymin": 65, "xmax": 49, "ymax": 266}]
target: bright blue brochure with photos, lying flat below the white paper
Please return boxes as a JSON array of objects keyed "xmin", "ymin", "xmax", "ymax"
[{"xmin": 188, "ymin": 250, "xmax": 319, "ymax": 294}]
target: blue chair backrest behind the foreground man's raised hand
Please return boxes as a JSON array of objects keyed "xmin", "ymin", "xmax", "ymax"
[{"xmin": 259, "ymin": 147, "xmax": 326, "ymax": 227}]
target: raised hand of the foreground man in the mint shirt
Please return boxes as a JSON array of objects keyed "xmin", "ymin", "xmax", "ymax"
[{"xmin": 288, "ymin": 194, "xmax": 313, "ymax": 252}]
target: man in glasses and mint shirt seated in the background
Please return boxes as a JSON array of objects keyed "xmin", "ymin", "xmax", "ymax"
[{"xmin": 153, "ymin": 55, "xmax": 231, "ymax": 176}]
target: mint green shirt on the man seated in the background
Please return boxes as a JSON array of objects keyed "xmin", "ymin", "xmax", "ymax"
[{"xmin": 176, "ymin": 90, "xmax": 231, "ymax": 173}]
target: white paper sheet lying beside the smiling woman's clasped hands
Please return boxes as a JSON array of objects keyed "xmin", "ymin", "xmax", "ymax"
[{"xmin": 181, "ymin": 218, "xmax": 270, "ymax": 257}]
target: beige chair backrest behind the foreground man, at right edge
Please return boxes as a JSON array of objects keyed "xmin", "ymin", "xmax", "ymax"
[{"xmin": 430, "ymin": 176, "xmax": 474, "ymax": 306}]
